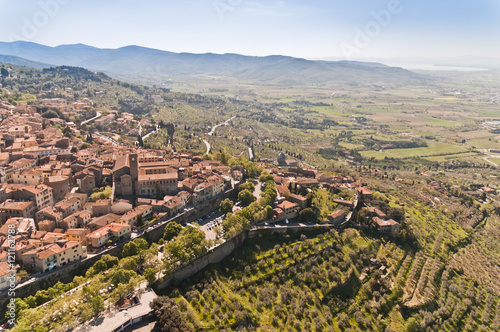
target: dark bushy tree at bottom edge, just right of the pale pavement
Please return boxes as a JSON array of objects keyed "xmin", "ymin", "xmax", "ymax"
[{"xmin": 149, "ymin": 296, "xmax": 194, "ymax": 332}]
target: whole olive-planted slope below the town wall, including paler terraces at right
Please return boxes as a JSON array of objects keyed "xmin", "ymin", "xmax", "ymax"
[{"xmin": 158, "ymin": 169, "xmax": 500, "ymax": 331}]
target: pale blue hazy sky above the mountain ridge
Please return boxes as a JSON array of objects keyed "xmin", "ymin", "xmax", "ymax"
[{"xmin": 0, "ymin": 0, "xmax": 500, "ymax": 58}]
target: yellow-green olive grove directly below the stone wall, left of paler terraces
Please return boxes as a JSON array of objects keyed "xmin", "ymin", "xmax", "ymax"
[{"xmin": 163, "ymin": 232, "xmax": 402, "ymax": 331}]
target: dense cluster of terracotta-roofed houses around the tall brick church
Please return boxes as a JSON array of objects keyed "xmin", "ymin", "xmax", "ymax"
[{"xmin": 0, "ymin": 99, "xmax": 238, "ymax": 290}]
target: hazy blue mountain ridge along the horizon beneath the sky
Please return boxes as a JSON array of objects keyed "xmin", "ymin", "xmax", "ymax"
[{"xmin": 0, "ymin": 41, "xmax": 427, "ymax": 85}]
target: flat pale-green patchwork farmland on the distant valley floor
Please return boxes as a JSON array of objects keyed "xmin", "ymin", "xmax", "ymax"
[{"xmin": 152, "ymin": 72, "xmax": 500, "ymax": 168}]
